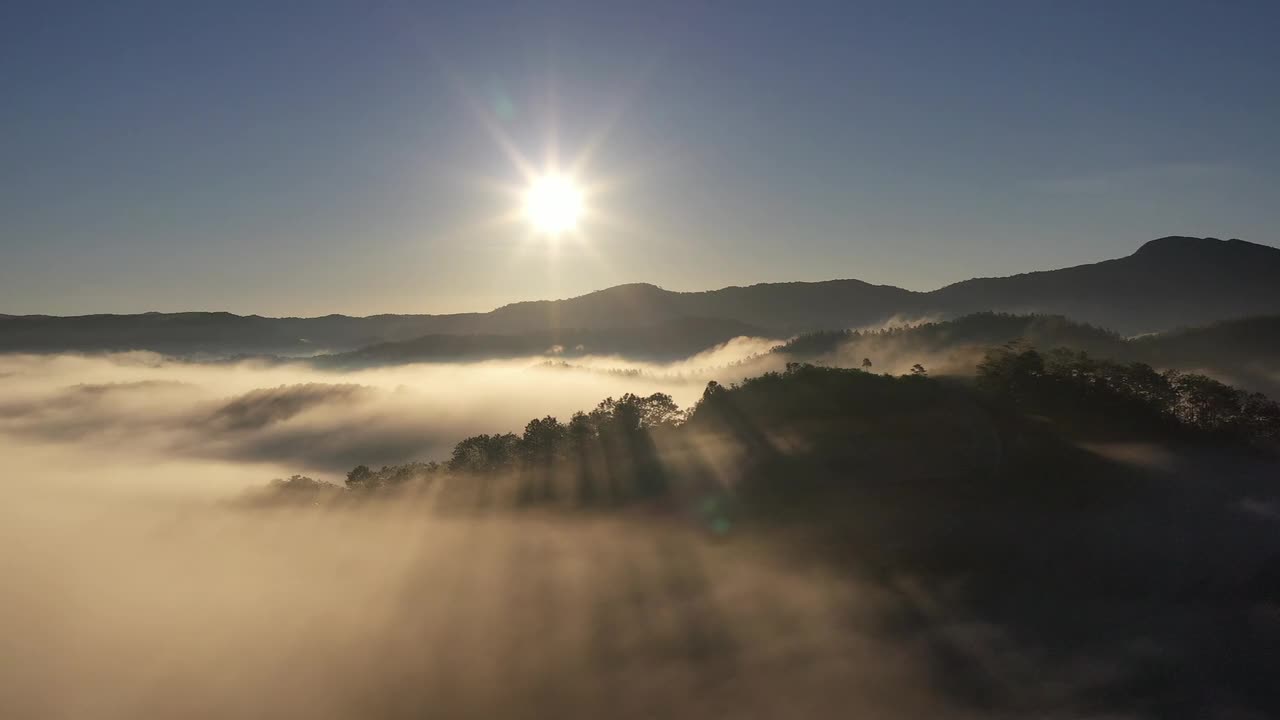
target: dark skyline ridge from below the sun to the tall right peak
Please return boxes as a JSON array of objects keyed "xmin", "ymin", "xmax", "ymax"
[{"xmin": 475, "ymin": 236, "xmax": 1280, "ymax": 334}]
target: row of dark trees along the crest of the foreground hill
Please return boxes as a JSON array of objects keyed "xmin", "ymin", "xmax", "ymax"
[{"xmin": 264, "ymin": 341, "xmax": 1280, "ymax": 502}]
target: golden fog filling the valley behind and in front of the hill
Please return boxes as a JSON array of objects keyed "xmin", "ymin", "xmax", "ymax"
[{"xmin": 0, "ymin": 345, "xmax": 1029, "ymax": 720}]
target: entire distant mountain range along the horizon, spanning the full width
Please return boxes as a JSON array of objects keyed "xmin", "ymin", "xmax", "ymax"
[{"xmin": 0, "ymin": 236, "xmax": 1280, "ymax": 355}]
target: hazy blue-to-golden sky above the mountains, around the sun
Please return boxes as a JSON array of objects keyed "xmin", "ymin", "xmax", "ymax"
[{"xmin": 0, "ymin": 0, "xmax": 1280, "ymax": 315}]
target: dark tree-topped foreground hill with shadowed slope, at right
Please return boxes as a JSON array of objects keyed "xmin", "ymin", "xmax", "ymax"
[{"xmin": 262, "ymin": 348, "xmax": 1280, "ymax": 717}]
